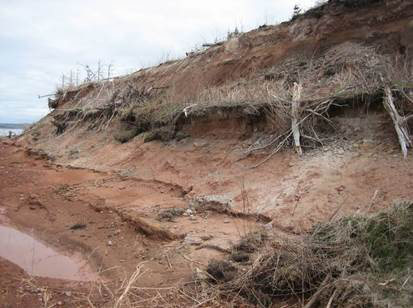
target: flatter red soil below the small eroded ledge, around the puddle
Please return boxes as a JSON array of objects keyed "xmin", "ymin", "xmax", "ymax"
[{"xmin": 0, "ymin": 142, "xmax": 254, "ymax": 307}]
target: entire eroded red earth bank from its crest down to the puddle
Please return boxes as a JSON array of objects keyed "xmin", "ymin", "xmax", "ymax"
[{"xmin": 0, "ymin": 0, "xmax": 413, "ymax": 307}]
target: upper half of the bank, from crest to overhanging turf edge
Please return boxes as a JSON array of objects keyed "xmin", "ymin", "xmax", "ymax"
[{"xmin": 25, "ymin": 0, "xmax": 413, "ymax": 149}]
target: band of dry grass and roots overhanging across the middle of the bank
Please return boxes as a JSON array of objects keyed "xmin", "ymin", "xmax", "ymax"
[{"xmin": 47, "ymin": 42, "xmax": 413, "ymax": 160}]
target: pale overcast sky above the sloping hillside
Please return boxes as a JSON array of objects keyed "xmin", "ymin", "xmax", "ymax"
[{"xmin": 0, "ymin": 0, "xmax": 315, "ymax": 123}]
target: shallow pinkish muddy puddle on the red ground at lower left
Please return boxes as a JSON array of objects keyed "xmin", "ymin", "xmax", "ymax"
[{"xmin": 0, "ymin": 225, "xmax": 97, "ymax": 281}]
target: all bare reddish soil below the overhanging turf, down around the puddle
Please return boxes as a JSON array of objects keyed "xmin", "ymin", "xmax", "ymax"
[{"xmin": 0, "ymin": 109, "xmax": 413, "ymax": 307}]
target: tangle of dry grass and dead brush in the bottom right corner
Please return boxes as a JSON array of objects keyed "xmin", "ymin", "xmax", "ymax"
[{"xmin": 208, "ymin": 202, "xmax": 413, "ymax": 307}]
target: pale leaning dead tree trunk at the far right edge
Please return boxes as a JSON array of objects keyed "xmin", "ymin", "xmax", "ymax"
[{"xmin": 383, "ymin": 86, "xmax": 412, "ymax": 158}]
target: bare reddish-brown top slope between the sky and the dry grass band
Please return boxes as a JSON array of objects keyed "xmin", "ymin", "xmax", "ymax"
[{"xmin": 51, "ymin": 0, "xmax": 413, "ymax": 108}]
